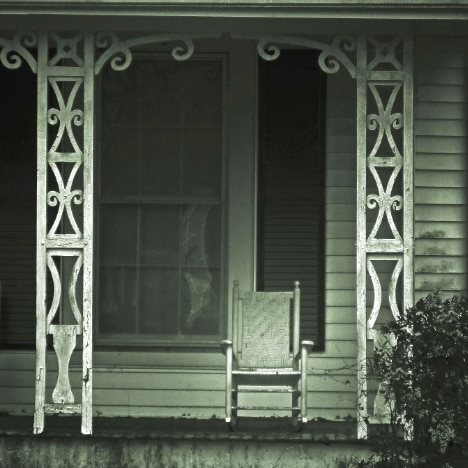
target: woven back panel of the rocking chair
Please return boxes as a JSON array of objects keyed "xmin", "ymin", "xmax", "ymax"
[{"xmin": 238, "ymin": 292, "xmax": 293, "ymax": 368}]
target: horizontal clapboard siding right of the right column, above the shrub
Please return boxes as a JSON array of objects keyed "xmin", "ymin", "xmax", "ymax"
[{"xmin": 414, "ymin": 37, "xmax": 468, "ymax": 300}]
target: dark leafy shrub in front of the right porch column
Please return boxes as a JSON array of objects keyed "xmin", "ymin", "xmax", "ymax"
[{"xmin": 358, "ymin": 294, "xmax": 468, "ymax": 467}]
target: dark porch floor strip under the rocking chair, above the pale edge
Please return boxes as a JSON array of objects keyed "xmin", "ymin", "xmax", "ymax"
[{"xmin": 0, "ymin": 415, "xmax": 356, "ymax": 443}]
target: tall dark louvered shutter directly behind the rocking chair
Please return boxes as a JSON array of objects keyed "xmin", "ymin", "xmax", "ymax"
[{"xmin": 257, "ymin": 50, "xmax": 326, "ymax": 349}]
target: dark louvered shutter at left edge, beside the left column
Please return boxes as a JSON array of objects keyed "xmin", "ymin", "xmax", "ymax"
[{"xmin": 0, "ymin": 65, "xmax": 37, "ymax": 348}]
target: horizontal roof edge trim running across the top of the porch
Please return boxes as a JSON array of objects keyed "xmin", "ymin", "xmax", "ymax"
[{"xmin": 0, "ymin": 0, "xmax": 468, "ymax": 20}]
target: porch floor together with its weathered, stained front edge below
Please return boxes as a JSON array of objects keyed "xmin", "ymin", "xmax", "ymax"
[{"xmin": 0, "ymin": 415, "xmax": 370, "ymax": 468}]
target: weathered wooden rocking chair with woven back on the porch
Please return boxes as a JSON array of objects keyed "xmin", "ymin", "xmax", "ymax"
[{"xmin": 222, "ymin": 281, "xmax": 314, "ymax": 430}]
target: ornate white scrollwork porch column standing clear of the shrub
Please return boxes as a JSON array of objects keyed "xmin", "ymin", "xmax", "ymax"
[{"xmin": 34, "ymin": 33, "xmax": 94, "ymax": 434}]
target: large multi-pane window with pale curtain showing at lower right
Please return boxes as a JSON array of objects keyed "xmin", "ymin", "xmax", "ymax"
[{"xmin": 97, "ymin": 54, "xmax": 225, "ymax": 344}]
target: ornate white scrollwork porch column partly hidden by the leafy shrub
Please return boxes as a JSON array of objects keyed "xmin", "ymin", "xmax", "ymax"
[{"xmin": 356, "ymin": 37, "xmax": 413, "ymax": 438}]
